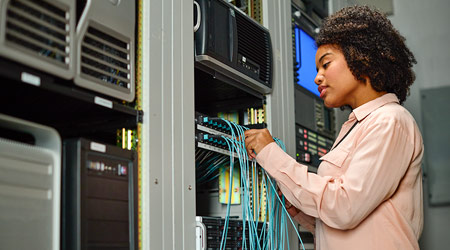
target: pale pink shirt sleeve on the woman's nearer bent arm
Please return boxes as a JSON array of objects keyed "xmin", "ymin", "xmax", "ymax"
[{"xmin": 256, "ymin": 120, "xmax": 414, "ymax": 230}]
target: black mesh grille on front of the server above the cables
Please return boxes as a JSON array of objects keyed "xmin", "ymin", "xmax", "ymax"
[{"xmin": 236, "ymin": 13, "xmax": 272, "ymax": 86}]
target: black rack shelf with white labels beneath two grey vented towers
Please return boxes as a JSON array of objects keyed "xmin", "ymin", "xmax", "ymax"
[{"xmin": 0, "ymin": 58, "xmax": 143, "ymax": 144}]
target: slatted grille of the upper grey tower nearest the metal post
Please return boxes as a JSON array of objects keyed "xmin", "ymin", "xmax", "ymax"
[{"xmin": 80, "ymin": 26, "xmax": 131, "ymax": 89}]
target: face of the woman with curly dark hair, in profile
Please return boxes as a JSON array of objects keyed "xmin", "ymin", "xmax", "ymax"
[{"xmin": 314, "ymin": 45, "xmax": 366, "ymax": 108}]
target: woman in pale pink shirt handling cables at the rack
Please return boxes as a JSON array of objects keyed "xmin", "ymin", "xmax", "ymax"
[{"xmin": 245, "ymin": 6, "xmax": 423, "ymax": 250}]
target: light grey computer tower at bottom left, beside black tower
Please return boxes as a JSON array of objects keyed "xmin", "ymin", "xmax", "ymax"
[{"xmin": 0, "ymin": 114, "xmax": 61, "ymax": 250}]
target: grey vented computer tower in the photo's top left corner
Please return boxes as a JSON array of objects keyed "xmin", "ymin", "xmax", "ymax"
[{"xmin": 0, "ymin": 0, "xmax": 76, "ymax": 79}]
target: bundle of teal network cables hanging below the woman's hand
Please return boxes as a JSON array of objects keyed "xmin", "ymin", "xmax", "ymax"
[{"xmin": 199, "ymin": 119, "xmax": 305, "ymax": 250}]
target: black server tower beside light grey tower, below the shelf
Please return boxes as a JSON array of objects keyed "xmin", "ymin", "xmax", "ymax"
[{"xmin": 62, "ymin": 138, "xmax": 138, "ymax": 250}]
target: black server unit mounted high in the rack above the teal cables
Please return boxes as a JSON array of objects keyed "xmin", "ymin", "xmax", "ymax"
[{"xmin": 194, "ymin": 0, "xmax": 273, "ymax": 94}]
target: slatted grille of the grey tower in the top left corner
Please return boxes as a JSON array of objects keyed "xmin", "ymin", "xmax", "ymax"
[{"xmin": 5, "ymin": 0, "xmax": 71, "ymax": 68}]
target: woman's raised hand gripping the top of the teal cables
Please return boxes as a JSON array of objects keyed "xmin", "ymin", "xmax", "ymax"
[{"xmin": 244, "ymin": 128, "xmax": 274, "ymax": 159}]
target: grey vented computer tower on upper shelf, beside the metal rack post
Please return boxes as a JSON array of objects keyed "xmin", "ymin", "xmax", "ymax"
[{"xmin": 74, "ymin": 0, "xmax": 135, "ymax": 102}]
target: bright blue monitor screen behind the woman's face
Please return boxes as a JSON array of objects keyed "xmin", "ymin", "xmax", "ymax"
[{"xmin": 295, "ymin": 26, "xmax": 320, "ymax": 96}]
